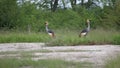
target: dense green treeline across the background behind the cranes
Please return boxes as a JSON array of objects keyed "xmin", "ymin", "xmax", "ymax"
[{"xmin": 0, "ymin": 0, "xmax": 120, "ymax": 31}]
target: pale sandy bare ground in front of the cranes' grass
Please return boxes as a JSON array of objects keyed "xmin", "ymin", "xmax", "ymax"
[{"xmin": 0, "ymin": 43, "xmax": 120, "ymax": 68}]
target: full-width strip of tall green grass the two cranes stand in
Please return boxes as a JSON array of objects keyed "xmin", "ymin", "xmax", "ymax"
[{"xmin": 0, "ymin": 29, "xmax": 120, "ymax": 46}]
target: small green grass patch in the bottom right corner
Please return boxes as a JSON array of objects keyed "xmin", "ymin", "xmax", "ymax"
[{"xmin": 104, "ymin": 55, "xmax": 120, "ymax": 68}]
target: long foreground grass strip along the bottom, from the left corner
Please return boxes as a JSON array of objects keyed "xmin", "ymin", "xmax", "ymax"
[{"xmin": 0, "ymin": 58, "xmax": 92, "ymax": 68}]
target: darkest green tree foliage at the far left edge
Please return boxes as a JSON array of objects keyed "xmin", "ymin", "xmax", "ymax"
[{"xmin": 0, "ymin": 0, "xmax": 18, "ymax": 29}]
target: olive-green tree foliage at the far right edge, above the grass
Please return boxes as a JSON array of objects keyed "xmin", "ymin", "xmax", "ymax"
[{"xmin": 102, "ymin": 0, "xmax": 120, "ymax": 28}]
